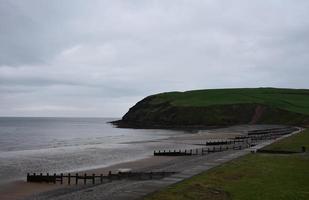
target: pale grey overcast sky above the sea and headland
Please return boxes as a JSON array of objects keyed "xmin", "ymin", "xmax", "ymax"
[{"xmin": 0, "ymin": 0, "xmax": 309, "ymax": 117}]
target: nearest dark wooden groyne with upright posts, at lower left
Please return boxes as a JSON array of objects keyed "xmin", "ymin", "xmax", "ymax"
[{"xmin": 27, "ymin": 171, "xmax": 176, "ymax": 185}]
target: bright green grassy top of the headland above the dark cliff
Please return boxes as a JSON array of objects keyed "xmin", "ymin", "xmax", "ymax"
[{"xmin": 153, "ymin": 88, "xmax": 309, "ymax": 115}]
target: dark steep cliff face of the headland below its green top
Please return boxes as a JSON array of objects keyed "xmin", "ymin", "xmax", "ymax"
[{"xmin": 114, "ymin": 88, "xmax": 309, "ymax": 128}]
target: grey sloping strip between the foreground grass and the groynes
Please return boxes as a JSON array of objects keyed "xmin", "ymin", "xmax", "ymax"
[{"xmin": 28, "ymin": 127, "xmax": 299, "ymax": 200}]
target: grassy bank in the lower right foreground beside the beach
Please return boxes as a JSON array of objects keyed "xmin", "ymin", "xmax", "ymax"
[{"xmin": 145, "ymin": 131, "xmax": 309, "ymax": 200}]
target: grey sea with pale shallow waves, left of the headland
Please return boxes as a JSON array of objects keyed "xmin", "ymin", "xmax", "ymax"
[{"xmin": 0, "ymin": 117, "xmax": 184, "ymax": 183}]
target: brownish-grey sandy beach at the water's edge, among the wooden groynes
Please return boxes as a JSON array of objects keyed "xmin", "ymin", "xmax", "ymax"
[{"xmin": 0, "ymin": 125, "xmax": 286, "ymax": 199}]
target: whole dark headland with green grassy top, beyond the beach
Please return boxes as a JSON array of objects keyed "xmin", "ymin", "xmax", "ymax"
[{"xmin": 114, "ymin": 88, "xmax": 309, "ymax": 128}]
